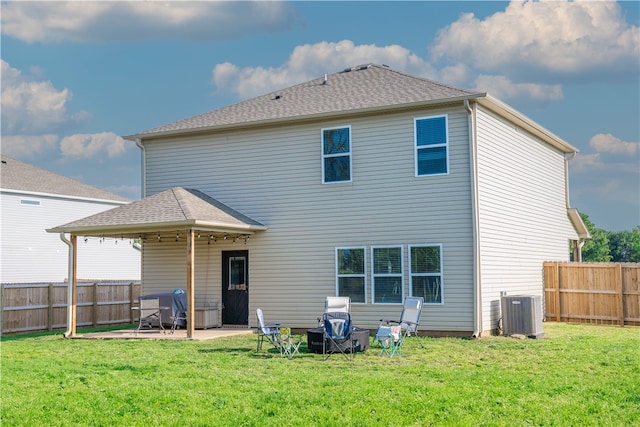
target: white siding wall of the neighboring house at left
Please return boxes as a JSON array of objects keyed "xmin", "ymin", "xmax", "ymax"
[{"xmin": 0, "ymin": 192, "xmax": 141, "ymax": 283}]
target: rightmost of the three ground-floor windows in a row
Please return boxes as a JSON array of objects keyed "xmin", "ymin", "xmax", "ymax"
[{"xmin": 409, "ymin": 245, "xmax": 443, "ymax": 304}]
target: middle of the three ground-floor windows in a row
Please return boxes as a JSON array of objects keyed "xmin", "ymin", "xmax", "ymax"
[{"xmin": 371, "ymin": 246, "xmax": 404, "ymax": 304}]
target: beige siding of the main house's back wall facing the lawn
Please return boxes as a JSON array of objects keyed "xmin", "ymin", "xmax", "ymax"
[{"xmin": 143, "ymin": 107, "xmax": 473, "ymax": 332}]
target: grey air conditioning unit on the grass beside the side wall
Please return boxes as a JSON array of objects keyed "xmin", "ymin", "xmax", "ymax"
[{"xmin": 501, "ymin": 295, "xmax": 544, "ymax": 338}]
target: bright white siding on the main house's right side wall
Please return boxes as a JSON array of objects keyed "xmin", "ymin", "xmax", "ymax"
[{"xmin": 477, "ymin": 107, "xmax": 577, "ymax": 331}]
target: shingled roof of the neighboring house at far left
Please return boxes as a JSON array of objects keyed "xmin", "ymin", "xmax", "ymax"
[{"xmin": 0, "ymin": 156, "xmax": 131, "ymax": 202}]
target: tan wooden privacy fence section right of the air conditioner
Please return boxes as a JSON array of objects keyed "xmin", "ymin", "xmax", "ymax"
[{"xmin": 543, "ymin": 262, "xmax": 640, "ymax": 326}]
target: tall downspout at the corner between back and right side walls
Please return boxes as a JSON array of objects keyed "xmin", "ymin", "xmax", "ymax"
[{"xmin": 464, "ymin": 99, "xmax": 482, "ymax": 338}]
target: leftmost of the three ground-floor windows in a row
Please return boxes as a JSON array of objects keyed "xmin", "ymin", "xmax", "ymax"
[{"xmin": 336, "ymin": 248, "xmax": 367, "ymax": 303}]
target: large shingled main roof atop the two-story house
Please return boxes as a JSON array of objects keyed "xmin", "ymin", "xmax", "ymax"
[{"xmin": 125, "ymin": 64, "xmax": 485, "ymax": 140}]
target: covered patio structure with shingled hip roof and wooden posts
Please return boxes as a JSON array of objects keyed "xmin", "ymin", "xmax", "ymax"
[{"xmin": 47, "ymin": 187, "xmax": 267, "ymax": 339}]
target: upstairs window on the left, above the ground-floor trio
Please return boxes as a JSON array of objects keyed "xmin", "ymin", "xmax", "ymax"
[{"xmin": 322, "ymin": 126, "xmax": 351, "ymax": 184}]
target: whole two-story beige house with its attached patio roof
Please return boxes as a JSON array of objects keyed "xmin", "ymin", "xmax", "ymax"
[{"xmin": 51, "ymin": 64, "xmax": 588, "ymax": 336}]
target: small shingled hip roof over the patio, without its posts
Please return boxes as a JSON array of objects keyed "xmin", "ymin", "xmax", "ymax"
[{"xmin": 47, "ymin": 187, "xmax": 267, "ymax": 237}]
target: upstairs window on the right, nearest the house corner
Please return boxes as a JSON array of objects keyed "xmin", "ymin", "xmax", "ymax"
[{"xmin": 414, "ymin": 115, "xmax": 449, "ymax": 176}]
